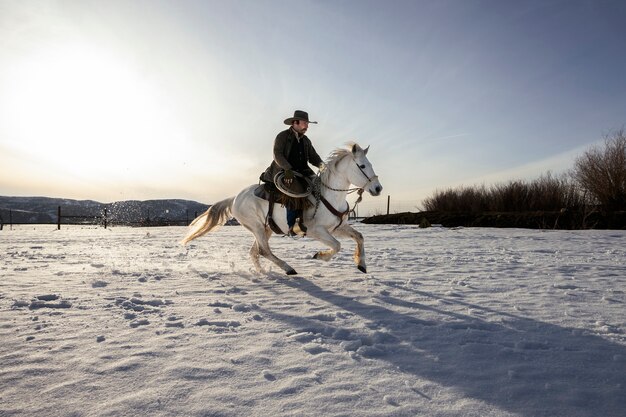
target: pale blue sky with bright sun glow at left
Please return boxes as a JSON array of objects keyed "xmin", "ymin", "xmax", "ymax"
[{"xmin": 0, "ymin": 0, "xmax": 626, "ymax": 211}]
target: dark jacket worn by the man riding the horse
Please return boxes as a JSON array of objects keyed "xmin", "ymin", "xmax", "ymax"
[{"xmin": 261, "ymin": 128, "xmax": 323, "ymax": 182}]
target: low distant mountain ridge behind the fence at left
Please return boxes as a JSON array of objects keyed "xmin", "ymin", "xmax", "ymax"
[{"xmin": 0, "ymin": 196, "xmax": 209, "ymax": 226}]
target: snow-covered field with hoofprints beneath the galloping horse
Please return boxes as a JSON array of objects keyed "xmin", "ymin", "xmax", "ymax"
[{"xmin": 0, "ymin": 224, "xmax": 626, "ymax": 417}]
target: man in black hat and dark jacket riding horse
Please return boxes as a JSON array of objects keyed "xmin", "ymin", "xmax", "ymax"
[{"xmin": 261, "ymin": 110, "xmax": 324, "ymax": 235}]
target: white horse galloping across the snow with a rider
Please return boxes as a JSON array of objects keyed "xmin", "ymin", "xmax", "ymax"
[{"xmin": 181, "ymin": 143, "xmax": 383, "ymax": 275}]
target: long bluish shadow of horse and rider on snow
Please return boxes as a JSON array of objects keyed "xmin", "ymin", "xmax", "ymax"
[{"xmin": 266, "ymin": 278, "xmax": 626, "ymax": 417}]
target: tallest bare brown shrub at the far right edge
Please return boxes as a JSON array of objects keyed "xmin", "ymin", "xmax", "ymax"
[{"xmin": 573, "ymin": 128, "xmax": 626, "ymax": 210}]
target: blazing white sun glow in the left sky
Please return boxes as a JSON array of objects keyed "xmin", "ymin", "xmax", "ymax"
[{"xmin": 3, "ymin": 44, "xmax": 184, "ymax": 179}]
